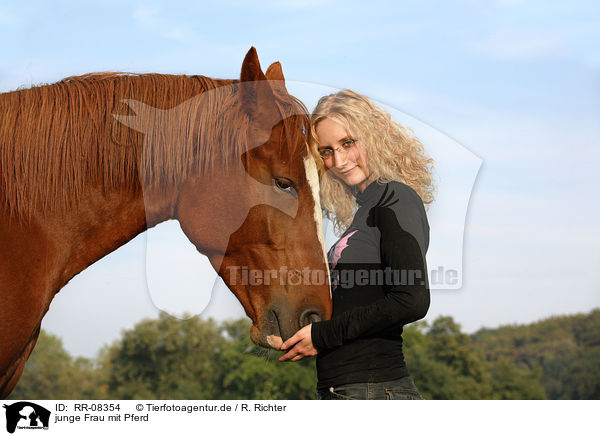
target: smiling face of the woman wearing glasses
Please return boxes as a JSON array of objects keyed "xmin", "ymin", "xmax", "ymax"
[{"xmin": 315, "ymin": 118, "xmax": 370, "ymax": 191}]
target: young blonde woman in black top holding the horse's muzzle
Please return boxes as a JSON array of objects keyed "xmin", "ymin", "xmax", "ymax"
[{"xmin": 280, "ymin": 90, "xmax": 433, "ymax": 399}]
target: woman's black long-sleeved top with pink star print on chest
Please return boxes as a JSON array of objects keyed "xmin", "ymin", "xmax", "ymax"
[{"xmin": 311, "ymin": 181, "xmax": 429, "ymax": 389}]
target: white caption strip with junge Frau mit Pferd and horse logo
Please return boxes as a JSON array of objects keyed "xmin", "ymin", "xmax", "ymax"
[{"xmin": 0, "ymin": 400, "xmax": 600, "ymax": 436}]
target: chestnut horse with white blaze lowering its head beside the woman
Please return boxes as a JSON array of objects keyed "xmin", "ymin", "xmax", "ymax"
[{"xmin": 0, "ymin": 47, "xmax": 331, "ymax": 398}]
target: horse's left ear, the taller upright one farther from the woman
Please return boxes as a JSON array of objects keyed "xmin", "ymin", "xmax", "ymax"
[{"xmin": 240, "ymin": 47, "xmax": 274, "ymax": 118}]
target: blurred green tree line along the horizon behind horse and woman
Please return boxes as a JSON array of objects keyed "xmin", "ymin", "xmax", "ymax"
[{"xmin": 9, "ymin": 309, "xmax": 600, "ymax": 400}]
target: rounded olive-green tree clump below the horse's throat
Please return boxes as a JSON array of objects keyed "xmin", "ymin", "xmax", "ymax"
[{"xmin": 102, "ymin": 314, "xmax": 226, "ymax": 400}]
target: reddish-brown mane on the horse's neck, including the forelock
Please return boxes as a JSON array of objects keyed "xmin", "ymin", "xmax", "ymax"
[{"xmin": 0, "ymin": 72, "xmax": 309, "ymax": 220}]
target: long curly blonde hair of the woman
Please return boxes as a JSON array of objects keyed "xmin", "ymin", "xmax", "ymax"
[{"xmin": 310, "ymin": 89, "xmax": 434, "ymax": 234}]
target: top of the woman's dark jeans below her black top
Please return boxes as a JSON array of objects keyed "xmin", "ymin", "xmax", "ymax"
[{"xmin": 317, "ymin": 377, "xmax": 423, "ymax": 400}]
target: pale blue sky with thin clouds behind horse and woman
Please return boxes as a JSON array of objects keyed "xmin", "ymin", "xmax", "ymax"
[{"xmin": 0, "ymin": 0, "xmax": 600, "ymax": 356}]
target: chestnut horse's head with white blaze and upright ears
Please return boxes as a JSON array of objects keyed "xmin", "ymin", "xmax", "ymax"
[{"xmin": 115, "ymin": 48, "xmax": 331, "ymax": 348}]
